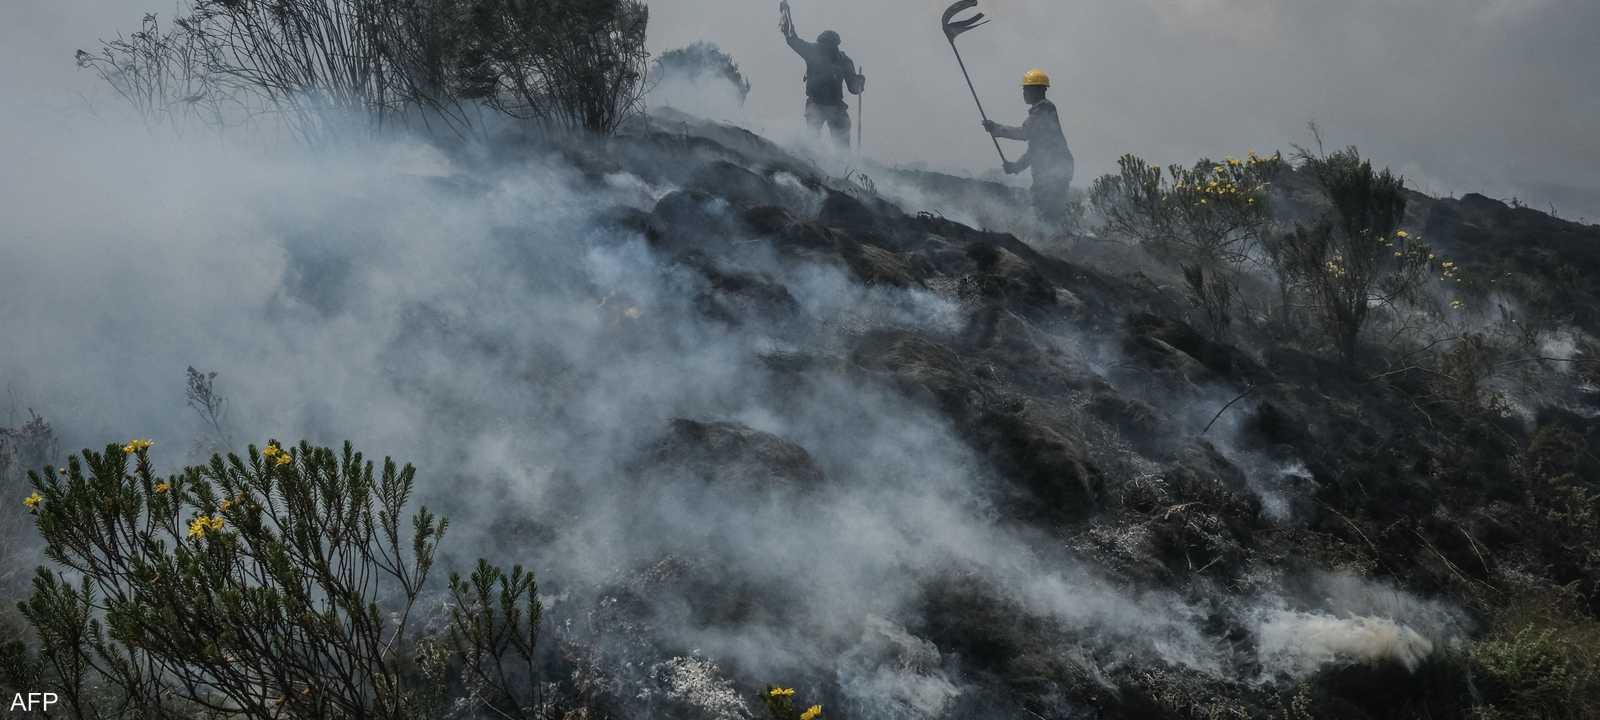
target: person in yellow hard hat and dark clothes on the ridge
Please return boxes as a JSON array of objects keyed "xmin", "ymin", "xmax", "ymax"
[{"xmin": 984, "ymin": 69, "xmax": 1074, "ymax": 227}]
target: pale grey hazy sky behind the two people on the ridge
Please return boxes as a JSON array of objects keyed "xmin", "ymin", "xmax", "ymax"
[{"xmin": 0, "ymin": 0, "xmax": 1600, "ymax": 214}]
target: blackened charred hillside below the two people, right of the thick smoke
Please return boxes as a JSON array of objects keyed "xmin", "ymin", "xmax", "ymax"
[{"xmin": 528, "ymin": 111, "xmax": 1600, "ymax": 717}]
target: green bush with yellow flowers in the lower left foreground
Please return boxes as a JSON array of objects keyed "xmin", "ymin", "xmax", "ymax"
[{"xmin": 12, "ymin": 440, "xmax": 539, "ymax": 718}]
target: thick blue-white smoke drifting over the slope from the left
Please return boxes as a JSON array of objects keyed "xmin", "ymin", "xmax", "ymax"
[{"xmin": 0, "ymin": 94, "xmax": 1478, "ymax": 718}]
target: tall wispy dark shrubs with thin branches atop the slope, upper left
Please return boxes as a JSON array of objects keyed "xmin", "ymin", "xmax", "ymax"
[{"xmin": 77, "ymin": 0, "xmax": 650, "ymax": 142}]
